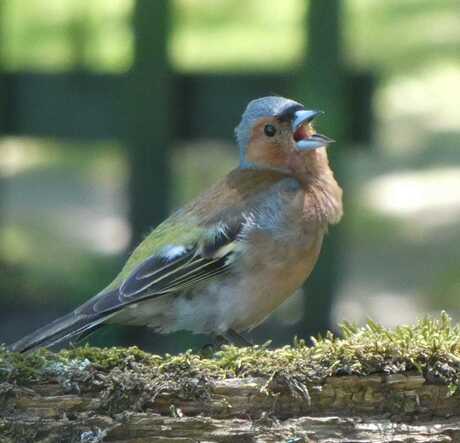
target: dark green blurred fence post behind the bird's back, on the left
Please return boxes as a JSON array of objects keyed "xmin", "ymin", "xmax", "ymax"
[{"xmin": 122, "ymin": 0, "xmax": 171, "ymax": 244}]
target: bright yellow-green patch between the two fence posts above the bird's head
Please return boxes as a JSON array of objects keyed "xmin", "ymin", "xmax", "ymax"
[{"xmin": 170, "ymin": 0, "xmax": 306, "ymax": 71}]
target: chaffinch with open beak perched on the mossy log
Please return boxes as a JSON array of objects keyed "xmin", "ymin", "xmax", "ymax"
[{"xmin": 10, "ymin": 96, "xmax": 343, "ymax": 352}]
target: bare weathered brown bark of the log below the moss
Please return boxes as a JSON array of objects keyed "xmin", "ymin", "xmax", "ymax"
[{"xmin": 0, "ymin": 361, "xmax": 460, "ymax": 443}]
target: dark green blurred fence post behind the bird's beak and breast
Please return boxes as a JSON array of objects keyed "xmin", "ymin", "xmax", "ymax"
[{"xmin": 297, "ymin": 0, "xmax": 348, "ymax": 337}]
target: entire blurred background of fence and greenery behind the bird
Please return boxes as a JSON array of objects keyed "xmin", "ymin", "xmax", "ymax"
[{"xmin": 0, "ymin": 0, "xmax": 460, "ymax": 352}]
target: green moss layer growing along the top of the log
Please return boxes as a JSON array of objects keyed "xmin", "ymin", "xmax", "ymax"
[{"xmin": 0, "ymin": 313, "xmax": 460, "ymax": 389}]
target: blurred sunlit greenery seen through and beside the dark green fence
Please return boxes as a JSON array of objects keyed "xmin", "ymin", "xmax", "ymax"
[{"xmin": 0, "ymin": 0, "xmax": 460, "ymax": 346}]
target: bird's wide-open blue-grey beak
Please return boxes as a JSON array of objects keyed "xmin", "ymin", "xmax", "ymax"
[{"xmin": 292, "ymin": 109, "xmax": 334, "ymax": 151}]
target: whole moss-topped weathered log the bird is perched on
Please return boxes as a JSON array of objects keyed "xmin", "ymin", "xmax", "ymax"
[{"xmin": 0, "ymin": 318, "xmax": 460, "ymax": 443}]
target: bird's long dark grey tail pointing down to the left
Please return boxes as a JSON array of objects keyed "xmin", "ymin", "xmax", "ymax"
[{"xmin": 10, "ymin": 312, "xmax": 111, "ymax": 352}]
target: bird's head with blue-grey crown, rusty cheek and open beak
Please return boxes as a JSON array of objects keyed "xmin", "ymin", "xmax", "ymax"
[{"xmin": 235, "ymin": 97, "xmax": 333, "ymax": 172}]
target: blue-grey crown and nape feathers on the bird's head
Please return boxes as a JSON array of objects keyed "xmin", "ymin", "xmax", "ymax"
[{"xmin": 235, "ymin": 96, "xmax": 299, "ymax": 157}]
